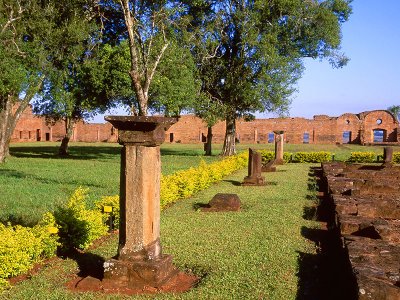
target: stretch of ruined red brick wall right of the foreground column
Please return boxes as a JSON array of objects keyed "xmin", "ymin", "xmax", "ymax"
[{"xmin": 167, "ymin": 110, "xmax": 400, "ymax": 144}]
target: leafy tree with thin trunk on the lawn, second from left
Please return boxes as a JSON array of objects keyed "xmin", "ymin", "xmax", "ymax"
[{"xmin": 34, "ymin": 0, "xmax": 109, "ymax": 155}]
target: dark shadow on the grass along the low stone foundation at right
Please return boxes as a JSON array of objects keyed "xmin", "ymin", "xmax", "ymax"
[{"xmin": 296, "ymin": 168, "xmax": 358, "ymax": 300}]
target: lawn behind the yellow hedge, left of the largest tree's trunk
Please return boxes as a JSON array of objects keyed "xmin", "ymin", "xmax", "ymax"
[{"xmin": 0, "ymin": 143, "xmax": 219, "ymax": 224}]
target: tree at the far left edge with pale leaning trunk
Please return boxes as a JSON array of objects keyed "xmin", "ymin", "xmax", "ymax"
[{"xmin": 0, "ymin": 0, "xmax": 51, "ymax": 163}]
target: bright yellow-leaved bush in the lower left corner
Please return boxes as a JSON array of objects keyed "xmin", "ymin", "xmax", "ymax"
[{"xmin": 0, "ymin": 213, "xmax": 59, "ymax": 290}]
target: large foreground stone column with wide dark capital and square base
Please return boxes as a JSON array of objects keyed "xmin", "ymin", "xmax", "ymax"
[{"xmin": 103, "ymin": 116, "xmax": 178, "ymax": 289}]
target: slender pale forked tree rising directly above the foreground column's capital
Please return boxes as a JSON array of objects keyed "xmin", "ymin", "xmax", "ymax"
[{"xmin": 108, "ymin": 0, "xmax": 191, "ymax": 116}]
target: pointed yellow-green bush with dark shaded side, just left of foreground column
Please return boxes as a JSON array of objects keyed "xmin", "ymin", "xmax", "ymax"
[{"xmin": 55, "ymin": 188, "xmax": 108, "ymax": 250}]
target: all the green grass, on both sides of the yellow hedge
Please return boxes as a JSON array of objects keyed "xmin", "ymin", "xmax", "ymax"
[{"xmin": 0, "ymin": 143, "xmax": 392, "ymax": 300}]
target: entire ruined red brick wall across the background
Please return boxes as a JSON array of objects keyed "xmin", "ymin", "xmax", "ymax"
[{"xmin": 11, "ymin": 107, "xmax": 400, "ymax": 144}]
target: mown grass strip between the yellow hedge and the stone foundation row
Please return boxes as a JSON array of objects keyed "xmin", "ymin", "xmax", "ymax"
[{"xmin": 0, "ymin": 164, "xmax": 317, "ymax": 299}]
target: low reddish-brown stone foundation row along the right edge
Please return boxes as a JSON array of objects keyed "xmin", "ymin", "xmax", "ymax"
[{"xmin": 322, "ymin": 163, "xmax": 400, "ymax": 300}]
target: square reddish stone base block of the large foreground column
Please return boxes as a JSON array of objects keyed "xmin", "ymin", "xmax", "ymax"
[{"xmin": 102, "ymin": 255, "xmax": 178, "ymax": 291}]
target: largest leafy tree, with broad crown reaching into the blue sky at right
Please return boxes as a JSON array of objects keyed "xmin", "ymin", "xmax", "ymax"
[{"xmin": 184, "ymin": 0, "xmax": 351, "ymax": 155}]
